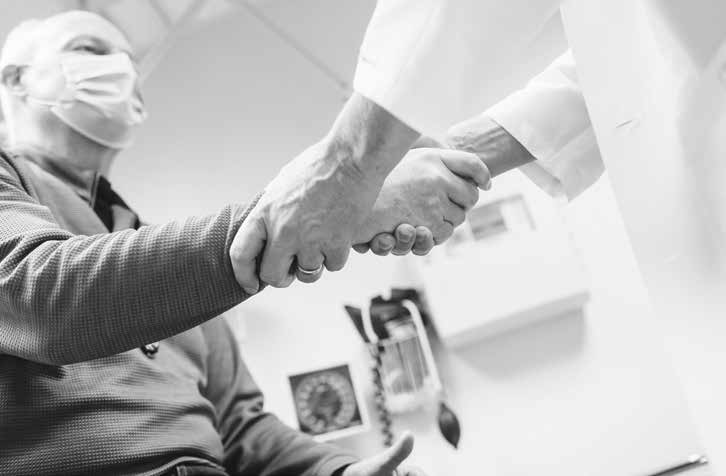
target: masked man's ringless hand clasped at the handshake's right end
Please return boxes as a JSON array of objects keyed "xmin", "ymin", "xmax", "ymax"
[{"xmin": 355, "ymin": 149, "xmax": 490, "ymax": 244}]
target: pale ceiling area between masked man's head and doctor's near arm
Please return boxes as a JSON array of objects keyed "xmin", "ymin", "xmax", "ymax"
[{"xmin": 115, "ymin": 1, "xmax": 372, "ymax": 221}]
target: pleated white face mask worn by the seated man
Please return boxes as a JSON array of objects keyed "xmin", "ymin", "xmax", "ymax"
[{"xmin": 28, "ymin": 53, "xmax": 146, "ymax": 149}]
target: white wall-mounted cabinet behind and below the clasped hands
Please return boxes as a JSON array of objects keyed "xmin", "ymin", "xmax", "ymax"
[{"xmin": 418, "ymin": 173, "xmax": 589, "ymax": 347}]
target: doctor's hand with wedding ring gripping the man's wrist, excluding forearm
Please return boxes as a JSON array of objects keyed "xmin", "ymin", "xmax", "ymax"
[{"xmin": 230, "ymin": 142, "xmax": 382, "ymax": 294}]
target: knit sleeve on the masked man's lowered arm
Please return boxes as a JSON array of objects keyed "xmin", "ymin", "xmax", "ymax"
[{"xmin": 202, "ymin": 317, "xmax": 357, "ymax": 476}]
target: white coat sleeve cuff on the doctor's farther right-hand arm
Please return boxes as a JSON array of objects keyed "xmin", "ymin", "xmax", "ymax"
[{"xmin": 486, "ymin": 51, "xmax": 604, "ymax": 199}]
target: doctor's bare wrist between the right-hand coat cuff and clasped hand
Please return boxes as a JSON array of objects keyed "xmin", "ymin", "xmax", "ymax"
[{"xmin": 446, "ymin": 115, "xmax": 536, "ymax": 177}]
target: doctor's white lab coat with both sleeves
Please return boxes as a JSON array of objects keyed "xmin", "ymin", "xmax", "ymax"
[{"xmin": 355, "ymin": 0, "xmax": 726, "ymax": 468}]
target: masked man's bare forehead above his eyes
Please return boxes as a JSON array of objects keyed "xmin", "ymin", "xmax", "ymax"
[{"xmin": 37, "ymin": 10, "xmax": 131, "ymax": 52}]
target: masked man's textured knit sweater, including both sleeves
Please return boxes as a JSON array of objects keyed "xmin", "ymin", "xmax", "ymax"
[{"xmin": 0, "ymin": 153, "xmax": 354, "ymax": 476}]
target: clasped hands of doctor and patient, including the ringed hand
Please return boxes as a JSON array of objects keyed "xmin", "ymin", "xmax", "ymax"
[{"xmin": 230, "ymin": 142, "xmax": 491, "ymax": 294}]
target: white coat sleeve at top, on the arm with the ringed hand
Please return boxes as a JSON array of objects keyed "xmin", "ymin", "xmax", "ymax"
[{"xmin": 354, "ymin": 0, "xmax": 561, "ymax": 140}]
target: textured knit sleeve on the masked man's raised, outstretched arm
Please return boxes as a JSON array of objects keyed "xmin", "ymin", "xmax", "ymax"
[{"xmin": 0, "ymin": 156, "xmax": 258, "ymax": 365}]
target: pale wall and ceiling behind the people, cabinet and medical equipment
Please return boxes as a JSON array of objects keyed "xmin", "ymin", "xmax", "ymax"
[{"xmin": 114, "ymin": 0, "xmax": 712, "ymax": 476}]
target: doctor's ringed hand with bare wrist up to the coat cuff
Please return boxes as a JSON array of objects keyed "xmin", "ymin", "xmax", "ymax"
[{"xmin": 229, "ymin": 93, "xmax": 419, "ymax": 294}]
